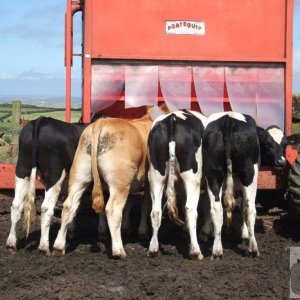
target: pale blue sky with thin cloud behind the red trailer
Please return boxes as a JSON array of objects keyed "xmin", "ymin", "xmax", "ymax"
[{"xmin": 0, "ymin": 0, "xmax": 300, "ymax": 97}]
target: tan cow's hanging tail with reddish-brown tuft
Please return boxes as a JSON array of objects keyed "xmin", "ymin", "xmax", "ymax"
[{"xmin": 91, "ymin": 122, "xmax": 104, "ymax": 213}]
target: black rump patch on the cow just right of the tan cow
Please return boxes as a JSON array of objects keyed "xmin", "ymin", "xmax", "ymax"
[{"xmin": 148, "ymin": 110, "xmax": 204, "ymax": 176}]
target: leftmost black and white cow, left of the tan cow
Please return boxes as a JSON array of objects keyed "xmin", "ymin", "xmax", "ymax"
[{"xmin": 6, "ymin": 117, "xmax": 87, "ymax": 254}]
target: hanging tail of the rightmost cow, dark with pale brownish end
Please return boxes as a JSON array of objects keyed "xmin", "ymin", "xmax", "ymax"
[{"xmin": 224, "ymin": 122, "xmax": 236, "ymax": 225}]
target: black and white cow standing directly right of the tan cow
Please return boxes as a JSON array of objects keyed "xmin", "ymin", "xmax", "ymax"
[{"xmin": 147, "ymin": 110, "xmax": 206, "ymax": 260}]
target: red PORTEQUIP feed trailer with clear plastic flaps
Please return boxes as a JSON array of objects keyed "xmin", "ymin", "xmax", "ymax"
[{"xmin": 0, "ymin": 0, "xmax": 298, "ymax": 206}]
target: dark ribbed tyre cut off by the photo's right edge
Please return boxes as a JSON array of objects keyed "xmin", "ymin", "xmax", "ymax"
[{"xmin": 286, "ymin": 155, "xmax": 300, "ymax": 218}]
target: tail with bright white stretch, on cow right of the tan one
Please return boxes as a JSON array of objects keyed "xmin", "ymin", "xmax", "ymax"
[{"xmin": 166, "ymin": 115, "xmax": 183, "ymax": 225}]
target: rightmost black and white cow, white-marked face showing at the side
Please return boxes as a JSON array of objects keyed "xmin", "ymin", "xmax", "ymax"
[{"xmin": 201, "ymin": 112, "xmax": 287, "ymax": 259}]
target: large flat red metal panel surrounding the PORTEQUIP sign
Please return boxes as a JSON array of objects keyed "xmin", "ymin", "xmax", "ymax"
[{"xmin": 89, "ymin": 0, "xmax": 288, "ymax": 61}]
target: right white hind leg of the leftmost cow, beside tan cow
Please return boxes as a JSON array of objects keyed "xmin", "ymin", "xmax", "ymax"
[{"xmin": 39, "ymin": 170, "xmax": 66, "ymax": 255}]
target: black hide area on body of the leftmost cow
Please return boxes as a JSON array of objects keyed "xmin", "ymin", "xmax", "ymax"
[{"xmin": 16, "ymin": 117, "xmax": 87, "ymax": 190}]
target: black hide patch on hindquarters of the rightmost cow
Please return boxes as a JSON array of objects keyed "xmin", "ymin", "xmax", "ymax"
[{"xmin": 202, "ymin": 115, "xmax": 260, "ymax": 191}]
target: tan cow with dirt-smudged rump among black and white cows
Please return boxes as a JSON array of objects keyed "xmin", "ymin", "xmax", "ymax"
[{"xmin": 53, "ymin": 105, "xmax": 168, "ymax": 257}]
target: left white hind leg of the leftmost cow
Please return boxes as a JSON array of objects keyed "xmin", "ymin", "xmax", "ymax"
[{"xmin": 6, "ymin": 177, "xmax": 29, "ymax": 251}]
